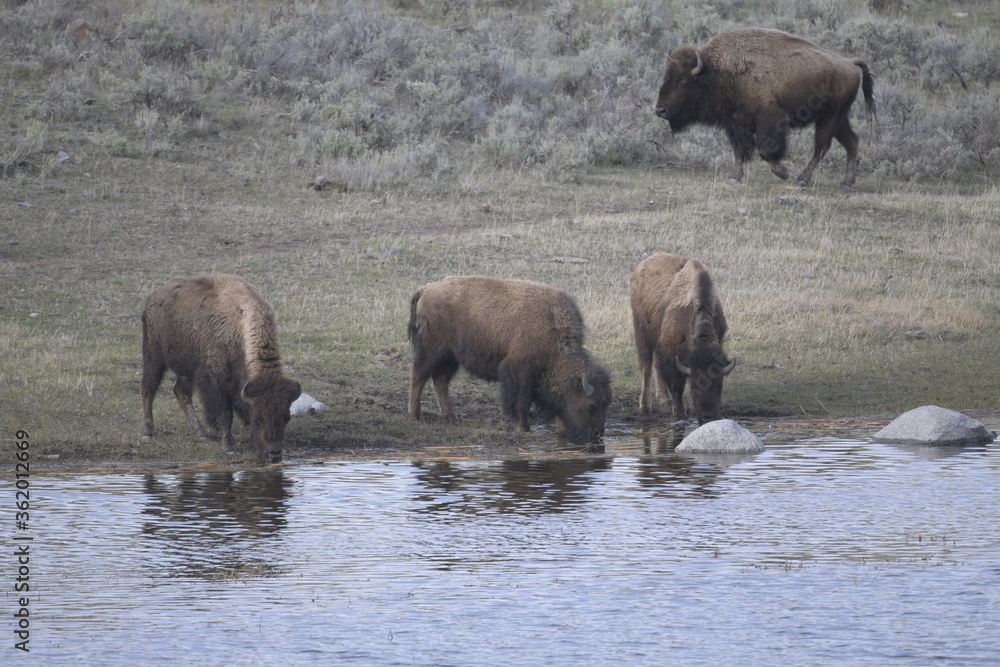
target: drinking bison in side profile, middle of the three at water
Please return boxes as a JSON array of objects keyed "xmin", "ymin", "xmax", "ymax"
[{"xmin": 408, "ymin": 276, "xmax": 611, "ymax": 441}]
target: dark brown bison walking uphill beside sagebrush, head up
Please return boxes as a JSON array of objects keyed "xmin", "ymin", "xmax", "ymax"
[{"xmin": 656, "ymin": 28, "xmax": 875, "ymax": 188}]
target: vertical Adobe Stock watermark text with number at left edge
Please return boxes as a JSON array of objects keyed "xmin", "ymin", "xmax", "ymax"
[{"xmin": 8, "ymin": 430, "xmax": 32, "ymax": 653}]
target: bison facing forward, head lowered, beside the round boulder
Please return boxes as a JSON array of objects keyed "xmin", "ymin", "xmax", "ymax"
[{"xmin": 628, "ymin": 252, "xmax": 736, "ymax": 423}]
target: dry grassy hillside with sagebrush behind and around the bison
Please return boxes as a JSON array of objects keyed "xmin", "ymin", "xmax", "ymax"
[{"xmin": 0, "ymin": 0, "xmax": 1000, "ymax": 464}]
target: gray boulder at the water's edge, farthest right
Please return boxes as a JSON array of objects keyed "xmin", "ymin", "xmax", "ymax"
[{"xmin": 873, "ymin": 405, "xmax": 996, "ymax": 446}]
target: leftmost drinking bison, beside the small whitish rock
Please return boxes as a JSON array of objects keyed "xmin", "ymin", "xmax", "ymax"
[{"xmin": 142, "ymin": 274, "xmax": 302, "ymax": 462}]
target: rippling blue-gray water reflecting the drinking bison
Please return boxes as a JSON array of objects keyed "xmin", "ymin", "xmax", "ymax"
[{"xmin": 13, "ymin": 425, "xmax": 1000, "ymax": 666}]
